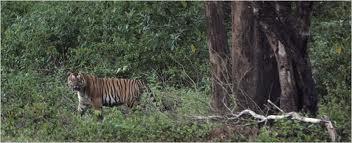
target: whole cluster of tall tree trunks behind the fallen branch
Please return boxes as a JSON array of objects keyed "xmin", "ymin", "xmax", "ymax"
[{"xmin": 206, "ymin": 2, "xmax": 317, "ymax": 113}]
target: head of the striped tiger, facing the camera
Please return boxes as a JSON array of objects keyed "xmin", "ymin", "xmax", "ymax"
[{"xmin": 67, "ymin": 73, "xmax": 87, "ymax": 91}]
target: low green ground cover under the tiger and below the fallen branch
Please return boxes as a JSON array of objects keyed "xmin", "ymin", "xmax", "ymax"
[{"xmin": 1, "ymin": 70, "xmax": 350, "ymax": 142}]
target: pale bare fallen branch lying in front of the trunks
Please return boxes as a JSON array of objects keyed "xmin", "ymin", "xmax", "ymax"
[{"xmin": 192, "ymin": 100, "xmax": 337, "ymax": 142}]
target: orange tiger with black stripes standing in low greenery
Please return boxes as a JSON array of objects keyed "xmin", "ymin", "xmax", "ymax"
[{"xmin": 67, "ymin": 72, "xmax": 153, "ymax": 120}]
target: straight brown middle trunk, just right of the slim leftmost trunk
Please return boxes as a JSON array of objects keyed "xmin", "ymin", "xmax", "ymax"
[{"xmin": 232, "ymin": 2, "xmax": 261, "ymax": 111}]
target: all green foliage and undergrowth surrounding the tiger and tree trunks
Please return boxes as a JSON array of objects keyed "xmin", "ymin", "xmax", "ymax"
[{"xmin": 1, "ymin": 1, "xmax": 351, "ymax": 141}]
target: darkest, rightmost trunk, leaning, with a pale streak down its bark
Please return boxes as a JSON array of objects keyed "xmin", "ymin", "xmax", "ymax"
[{"xmin": 253, "ymin": 2, "xmax": 317, "ymax": 113}]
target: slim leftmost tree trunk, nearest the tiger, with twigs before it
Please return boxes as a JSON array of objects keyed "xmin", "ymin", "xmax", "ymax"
[{"xmin": 205, "ymin": 1, "xmax": 231, "ymax": 114}]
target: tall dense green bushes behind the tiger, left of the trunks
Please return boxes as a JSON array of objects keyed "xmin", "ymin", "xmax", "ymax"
[{"xmin": 2, "ymin": 2, "xmax": 208, "ymax": 85}]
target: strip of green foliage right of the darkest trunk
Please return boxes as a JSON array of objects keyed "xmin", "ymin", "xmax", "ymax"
[{"xmin": 310, "ymin": 2, "xmax": 351, "ymax": 141}]
